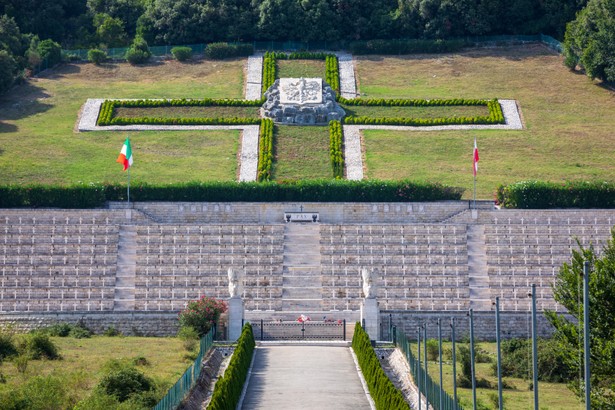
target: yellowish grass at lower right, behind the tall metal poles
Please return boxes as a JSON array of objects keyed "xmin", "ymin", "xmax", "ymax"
[{"xmin": 412, "ymin": 342, "xmax": 584, "ymax": 410}]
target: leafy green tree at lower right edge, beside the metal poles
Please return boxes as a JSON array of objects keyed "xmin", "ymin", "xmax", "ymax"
[{"xmin": 546, "ymin": 229, "xmax": 615, "ymax": 409}]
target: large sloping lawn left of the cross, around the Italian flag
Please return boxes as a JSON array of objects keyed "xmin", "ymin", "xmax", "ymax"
[{"xmin": 0, "ymin": 59, "xmax": 244, "ymax": 183}]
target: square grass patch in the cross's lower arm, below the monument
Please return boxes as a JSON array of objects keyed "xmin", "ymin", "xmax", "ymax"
[{"xmin": 272, "ymin": 125, "xmax": 333, "ymax": 181}]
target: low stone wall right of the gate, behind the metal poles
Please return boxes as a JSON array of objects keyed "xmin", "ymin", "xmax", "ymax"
[{"xmin": 380, "ymin": 310, "xmax": 568, "ymax": 341}]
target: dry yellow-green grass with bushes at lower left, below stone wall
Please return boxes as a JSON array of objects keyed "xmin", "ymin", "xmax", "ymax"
[{"xmin": 0, "ymin": 336, "xmax": 191, "ymax": 402}]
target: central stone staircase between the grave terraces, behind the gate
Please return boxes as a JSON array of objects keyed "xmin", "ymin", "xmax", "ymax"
[{"xmin": 282, "ymin": 223, "xmax": 322, "ymax": 313}]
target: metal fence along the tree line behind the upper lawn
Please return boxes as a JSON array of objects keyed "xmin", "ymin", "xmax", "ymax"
[{"xmin": 63, "ymin": 34, "xmax": 562, "ymax": 60}]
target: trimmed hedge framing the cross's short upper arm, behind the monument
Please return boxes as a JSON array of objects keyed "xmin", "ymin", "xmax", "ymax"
[{"xmin": 263, "ymin": 51, "xmax": 340, "ymax": 94}]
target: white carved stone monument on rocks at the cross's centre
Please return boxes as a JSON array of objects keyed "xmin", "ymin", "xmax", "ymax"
[{"xmin": 261, "ymin": 78, "xmax": 346, "ymax": 125}]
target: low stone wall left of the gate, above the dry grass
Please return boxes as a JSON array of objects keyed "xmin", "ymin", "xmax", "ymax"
[{"xmin": 0, "ymin": 312, "xmax": 179, "ymax": 336}]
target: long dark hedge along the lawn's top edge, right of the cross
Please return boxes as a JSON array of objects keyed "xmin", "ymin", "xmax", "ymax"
[{"xmin": 350, "ymin": 39, "xmax": 467, "ymax": 55}]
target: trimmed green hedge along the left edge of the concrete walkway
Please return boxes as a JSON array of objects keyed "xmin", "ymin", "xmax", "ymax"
[{"xmin": 207, "ymin": 323, "xmax": 255, "ymax": 410}]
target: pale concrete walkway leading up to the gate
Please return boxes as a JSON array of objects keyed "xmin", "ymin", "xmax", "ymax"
[{"xmin": 242, "ymin": 346, "xmax": 371, "ymax": 410}]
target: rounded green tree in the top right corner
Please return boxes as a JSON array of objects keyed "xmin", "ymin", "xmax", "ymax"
[{"xmin": 564, "ymin": 0, "xmax": 615, "ymax": 82}]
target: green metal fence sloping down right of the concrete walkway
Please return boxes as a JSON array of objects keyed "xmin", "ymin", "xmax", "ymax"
[{"xmin": 393, "ymin": 331, "xmax": 463, "ymax": 410}]
